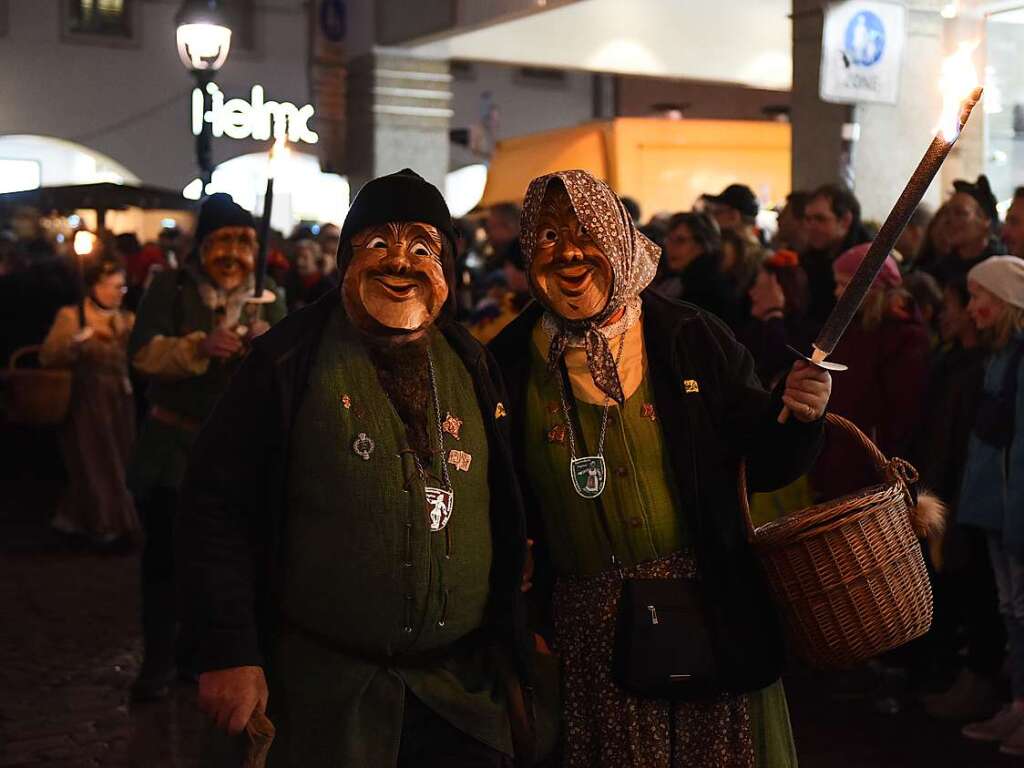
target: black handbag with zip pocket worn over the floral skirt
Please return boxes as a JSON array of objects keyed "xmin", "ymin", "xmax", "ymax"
[{"xmin": 611, "ymin": 579, "xmax": 723, "ymax": 701}]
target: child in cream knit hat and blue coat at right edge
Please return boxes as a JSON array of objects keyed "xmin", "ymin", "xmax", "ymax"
[{"xmin": 958, "ymin": 256, "xmax": 1024, "ymax": 757}]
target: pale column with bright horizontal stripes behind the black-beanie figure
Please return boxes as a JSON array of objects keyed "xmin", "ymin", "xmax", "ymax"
[{"xmin": 346, "ymin": 47, "xmax": 452, "ymax": 196}]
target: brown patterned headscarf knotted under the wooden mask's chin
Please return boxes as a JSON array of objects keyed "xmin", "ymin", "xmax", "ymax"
[{"xmin": 519, "ymin": 170, "xmax": 662, "ymax": 404}]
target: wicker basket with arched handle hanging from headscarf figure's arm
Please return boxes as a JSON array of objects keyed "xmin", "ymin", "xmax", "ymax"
[{"xmin": 740, "ymin": 414, "xmax": 932, "ymax": 669}]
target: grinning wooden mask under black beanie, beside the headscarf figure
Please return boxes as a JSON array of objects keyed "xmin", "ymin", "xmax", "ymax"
[{"xmin": 342, "ymin": 221, "xmax": 449, "ymax": 334}]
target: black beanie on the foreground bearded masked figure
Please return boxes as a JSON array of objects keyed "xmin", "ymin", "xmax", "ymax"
[{"xmin": 340, "ymin": 168, "xmax": 456, "ymax": 270}]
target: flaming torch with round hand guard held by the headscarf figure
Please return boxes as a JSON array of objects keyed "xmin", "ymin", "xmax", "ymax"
[{"xmin": 778, "ymin": 43, "xmax": 982, "ymax": 423}]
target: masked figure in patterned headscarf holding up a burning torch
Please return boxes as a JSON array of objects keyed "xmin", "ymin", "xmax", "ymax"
[{"xmin": 492, "ymin": 171, "xmax": 830, "ymax": 768}]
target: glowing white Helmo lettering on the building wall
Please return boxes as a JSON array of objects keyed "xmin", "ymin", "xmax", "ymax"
[{"xmin": 191, "ymin": 83, "xmax": 319, "ymax": 144}]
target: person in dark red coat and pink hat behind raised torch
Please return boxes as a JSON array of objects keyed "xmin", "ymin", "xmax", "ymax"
[{"xmin": 811, "ymin": 243, "xmax": 930, "ymax": 499}]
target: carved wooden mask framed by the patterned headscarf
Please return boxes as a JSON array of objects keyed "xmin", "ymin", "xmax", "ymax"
[{"xmin": 529, "ymin": 183, "xmax": 613, "ymax": 321}]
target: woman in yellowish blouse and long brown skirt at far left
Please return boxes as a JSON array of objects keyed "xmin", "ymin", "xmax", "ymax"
[{"xmin": 39, "ymin": 260, "xmax": 139, "ymax": 545}]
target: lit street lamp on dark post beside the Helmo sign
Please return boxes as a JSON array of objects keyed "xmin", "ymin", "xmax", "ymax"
[{"xmin": 174, "ymin": 0, "xmax": 231, "ymax": 194}]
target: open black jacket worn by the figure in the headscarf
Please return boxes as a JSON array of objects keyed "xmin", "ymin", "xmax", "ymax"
[{"xmin": 490, "ymin": 290, "xmax": 822, "ymax": 691}]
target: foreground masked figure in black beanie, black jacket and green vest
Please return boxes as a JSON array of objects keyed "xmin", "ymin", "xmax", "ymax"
[{"xmin": 178, "ymin": 170, "xmax": 529, "ymax": 768}]
